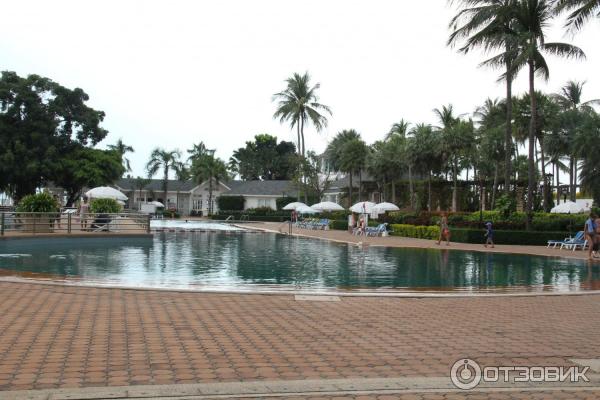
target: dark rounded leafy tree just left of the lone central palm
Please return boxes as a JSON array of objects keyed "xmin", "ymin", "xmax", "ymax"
[{"xmin": 229, "ymin": 134, "xmax": 298, "ymax": 180}]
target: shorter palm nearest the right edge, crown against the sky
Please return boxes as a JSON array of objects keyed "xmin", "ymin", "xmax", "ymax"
[{"xmin": 554, "ymin": 81, "xmax": 600, "ymax": 201}]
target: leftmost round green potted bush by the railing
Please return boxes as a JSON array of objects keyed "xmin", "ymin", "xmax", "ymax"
[{"xmin": 17, "ymin": 192, "xmax": 60, "ymax": 233}]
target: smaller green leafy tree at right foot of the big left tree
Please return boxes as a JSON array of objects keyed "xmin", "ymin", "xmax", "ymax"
[{"xmin": 53, "ymin": 144, "xmax": 125, "ymax": 205}]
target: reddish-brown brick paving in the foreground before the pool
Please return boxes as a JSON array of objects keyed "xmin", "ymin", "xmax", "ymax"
[{"xmin": 0, "ymin": 282, "xmax": 600, "ymax": 398}]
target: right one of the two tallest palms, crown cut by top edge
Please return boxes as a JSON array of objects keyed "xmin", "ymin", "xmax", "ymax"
[{"xmin": 483, "ymin": 0, "xmax": 585, "ymax": 229}]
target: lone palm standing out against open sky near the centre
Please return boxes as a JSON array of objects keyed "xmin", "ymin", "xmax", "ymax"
[{"xmin": 273, "ymin": 72, "xmax": 331, "ymax": 157}]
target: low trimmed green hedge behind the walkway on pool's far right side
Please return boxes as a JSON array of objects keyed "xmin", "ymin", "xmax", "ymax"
[{"xmin": 391, "ymin": 224, "xmax": 569, "ymax": 246}]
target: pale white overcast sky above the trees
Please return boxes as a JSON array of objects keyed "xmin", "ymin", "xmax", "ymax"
[{"xmin": 0, "ymin": 0, "xmax": 600, "ymax": 175}]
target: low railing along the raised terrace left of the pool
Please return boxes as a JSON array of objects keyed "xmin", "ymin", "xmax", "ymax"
[{"xmin": 0, "ymin": 210, "xmax": 150, "ymax": 236}]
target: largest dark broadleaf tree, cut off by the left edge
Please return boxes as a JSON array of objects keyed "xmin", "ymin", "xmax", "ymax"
[{"xmin": 0, "ymin": 71, "xmax": 108, "ymax": 202}]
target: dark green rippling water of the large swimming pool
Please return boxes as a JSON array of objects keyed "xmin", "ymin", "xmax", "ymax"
[{"xmin": 0, "ymin": 233, "xmax": 600, "ymax": 291}]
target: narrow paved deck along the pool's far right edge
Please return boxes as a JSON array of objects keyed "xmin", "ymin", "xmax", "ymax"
[{"xmin": 243, "ymin": 222, "xmax": 600, "ymax": 262}]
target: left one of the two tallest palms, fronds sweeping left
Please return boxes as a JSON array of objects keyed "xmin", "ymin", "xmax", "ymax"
[{"xmin": 448, "ymin": 0, "xmax": 517, "ymax": 194}]
